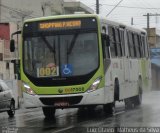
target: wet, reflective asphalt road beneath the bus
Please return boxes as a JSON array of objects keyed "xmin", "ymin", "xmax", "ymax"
[{"xmin": 0, "ymin": 91, "xmax": 160, "ymax": 133}]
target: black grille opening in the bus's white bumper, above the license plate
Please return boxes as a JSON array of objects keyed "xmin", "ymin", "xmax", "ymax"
[{"xmin": 40, "ymin": 96, "xmax": 82, "ymax": 105}]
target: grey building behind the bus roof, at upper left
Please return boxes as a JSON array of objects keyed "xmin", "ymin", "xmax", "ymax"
[{"xmin": 0, "ymin": 0, "xmax": 94, "ymax": 25}]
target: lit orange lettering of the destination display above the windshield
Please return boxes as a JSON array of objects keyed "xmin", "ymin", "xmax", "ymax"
[{"xmin": 39, "ymin": 20, "xmax": 81, "ymax": 30}]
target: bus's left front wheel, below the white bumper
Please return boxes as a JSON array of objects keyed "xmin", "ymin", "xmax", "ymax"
[{"xmin": 42, "ymin": 107, "xmax": 55, "ymax": 118}]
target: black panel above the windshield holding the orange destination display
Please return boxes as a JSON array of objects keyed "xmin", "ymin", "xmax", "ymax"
[{"xmin": 23, "ymin": 17, "xmax": 98, "ymax": 37}]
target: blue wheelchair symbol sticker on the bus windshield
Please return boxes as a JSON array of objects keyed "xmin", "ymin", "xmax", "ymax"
[{"xmin": 62, "ymin": 64, "xmax": 73, "ymax": 76}]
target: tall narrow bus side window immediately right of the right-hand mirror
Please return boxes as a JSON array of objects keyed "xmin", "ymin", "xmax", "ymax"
[{"xmin": 109, "ymin": 26, "xmax": 117, "ymax": 58}]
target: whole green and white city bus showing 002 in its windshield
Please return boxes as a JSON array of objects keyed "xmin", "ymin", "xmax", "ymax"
[{"xmin": 11, "ymin": 14, "xmax": 151, "ymax": 117}]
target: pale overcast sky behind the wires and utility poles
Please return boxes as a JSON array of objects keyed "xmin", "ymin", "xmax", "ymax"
[{"xmin": 77, "ymin": 0, "xmax": 160, "ymax": 29}]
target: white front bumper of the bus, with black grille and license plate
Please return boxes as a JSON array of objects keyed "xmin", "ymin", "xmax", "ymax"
[{"xmin": 23, "ymin": 88, "xmax": 104, "ymax": 108}]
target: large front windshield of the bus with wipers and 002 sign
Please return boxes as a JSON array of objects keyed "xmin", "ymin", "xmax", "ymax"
[{"xmin": 23, "ymin": 32, "xmax": 99, "ymax": 78}]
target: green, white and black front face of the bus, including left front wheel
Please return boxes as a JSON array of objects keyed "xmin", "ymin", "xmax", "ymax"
[{"xmin": 21, "ymin": 15, "xmax": 104, "ymax": 117}]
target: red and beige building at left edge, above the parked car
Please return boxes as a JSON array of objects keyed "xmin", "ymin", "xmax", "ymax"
[{"xmin": 0, "ymin": 23, "xmax": 16, "ymax": 80}]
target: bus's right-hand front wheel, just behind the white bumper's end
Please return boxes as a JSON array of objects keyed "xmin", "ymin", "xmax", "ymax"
[{"xmin": 103, "ymin": 102, "xmax": 115, "ymax": 115}]
